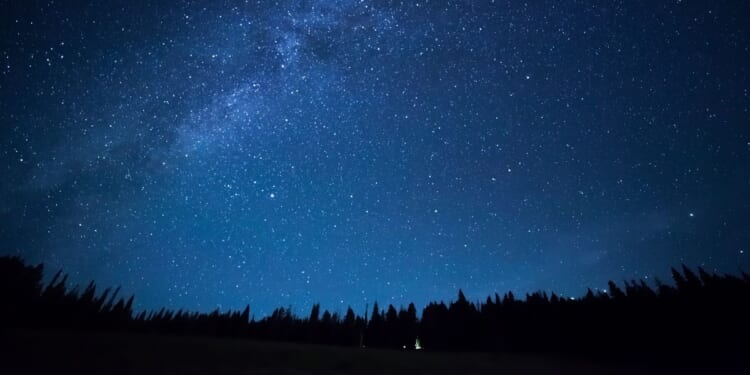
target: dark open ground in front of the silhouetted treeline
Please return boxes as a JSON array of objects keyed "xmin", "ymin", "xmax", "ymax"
[{"xmin": 0, "ymin": 331, "xmax": 739, "ymax": 375}]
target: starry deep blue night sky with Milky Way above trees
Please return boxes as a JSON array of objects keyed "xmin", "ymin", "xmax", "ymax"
[{"xmin": 0, "ymin": 0, "xmax": 750, "ymax": 317}]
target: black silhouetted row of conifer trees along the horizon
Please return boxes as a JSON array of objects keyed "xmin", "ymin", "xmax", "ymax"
[{"xmin": 0, "ymin": 257, "xmax": 750, "ymax": 359}]
